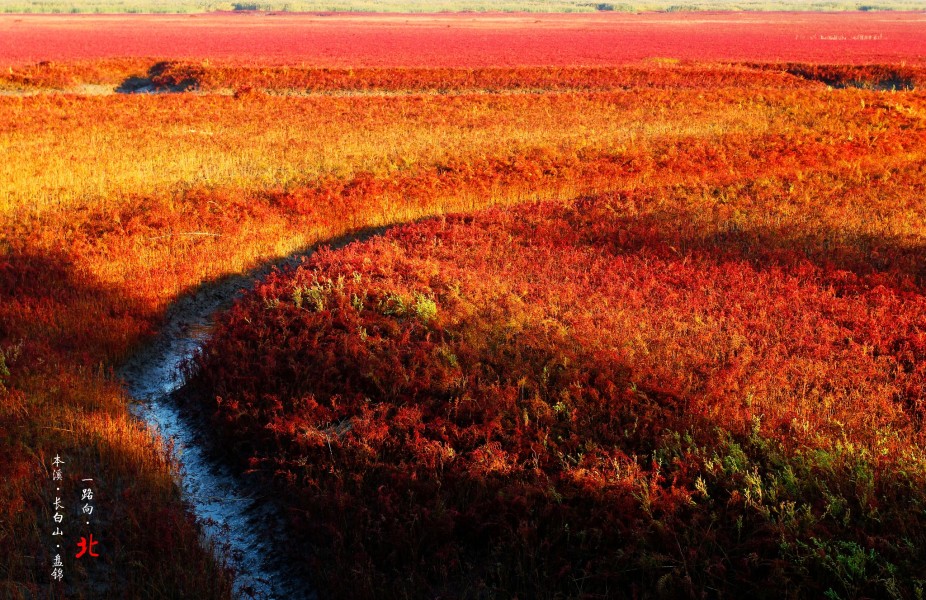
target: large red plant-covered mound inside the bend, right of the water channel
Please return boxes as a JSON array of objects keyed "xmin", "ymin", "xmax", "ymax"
[{"xmin": 191, "ymin": 173, "xmax": 926, "ymax": 598}]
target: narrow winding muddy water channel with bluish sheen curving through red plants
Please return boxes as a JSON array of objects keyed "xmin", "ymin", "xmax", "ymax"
[{"xmin": 118, "ymin": 229, "xmax": 382, "ymax": 600}]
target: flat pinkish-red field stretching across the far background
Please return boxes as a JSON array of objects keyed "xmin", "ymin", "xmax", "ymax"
[{"xmin": 0, "ymin": 12, "xmax": 926, "ymax": 68}]
